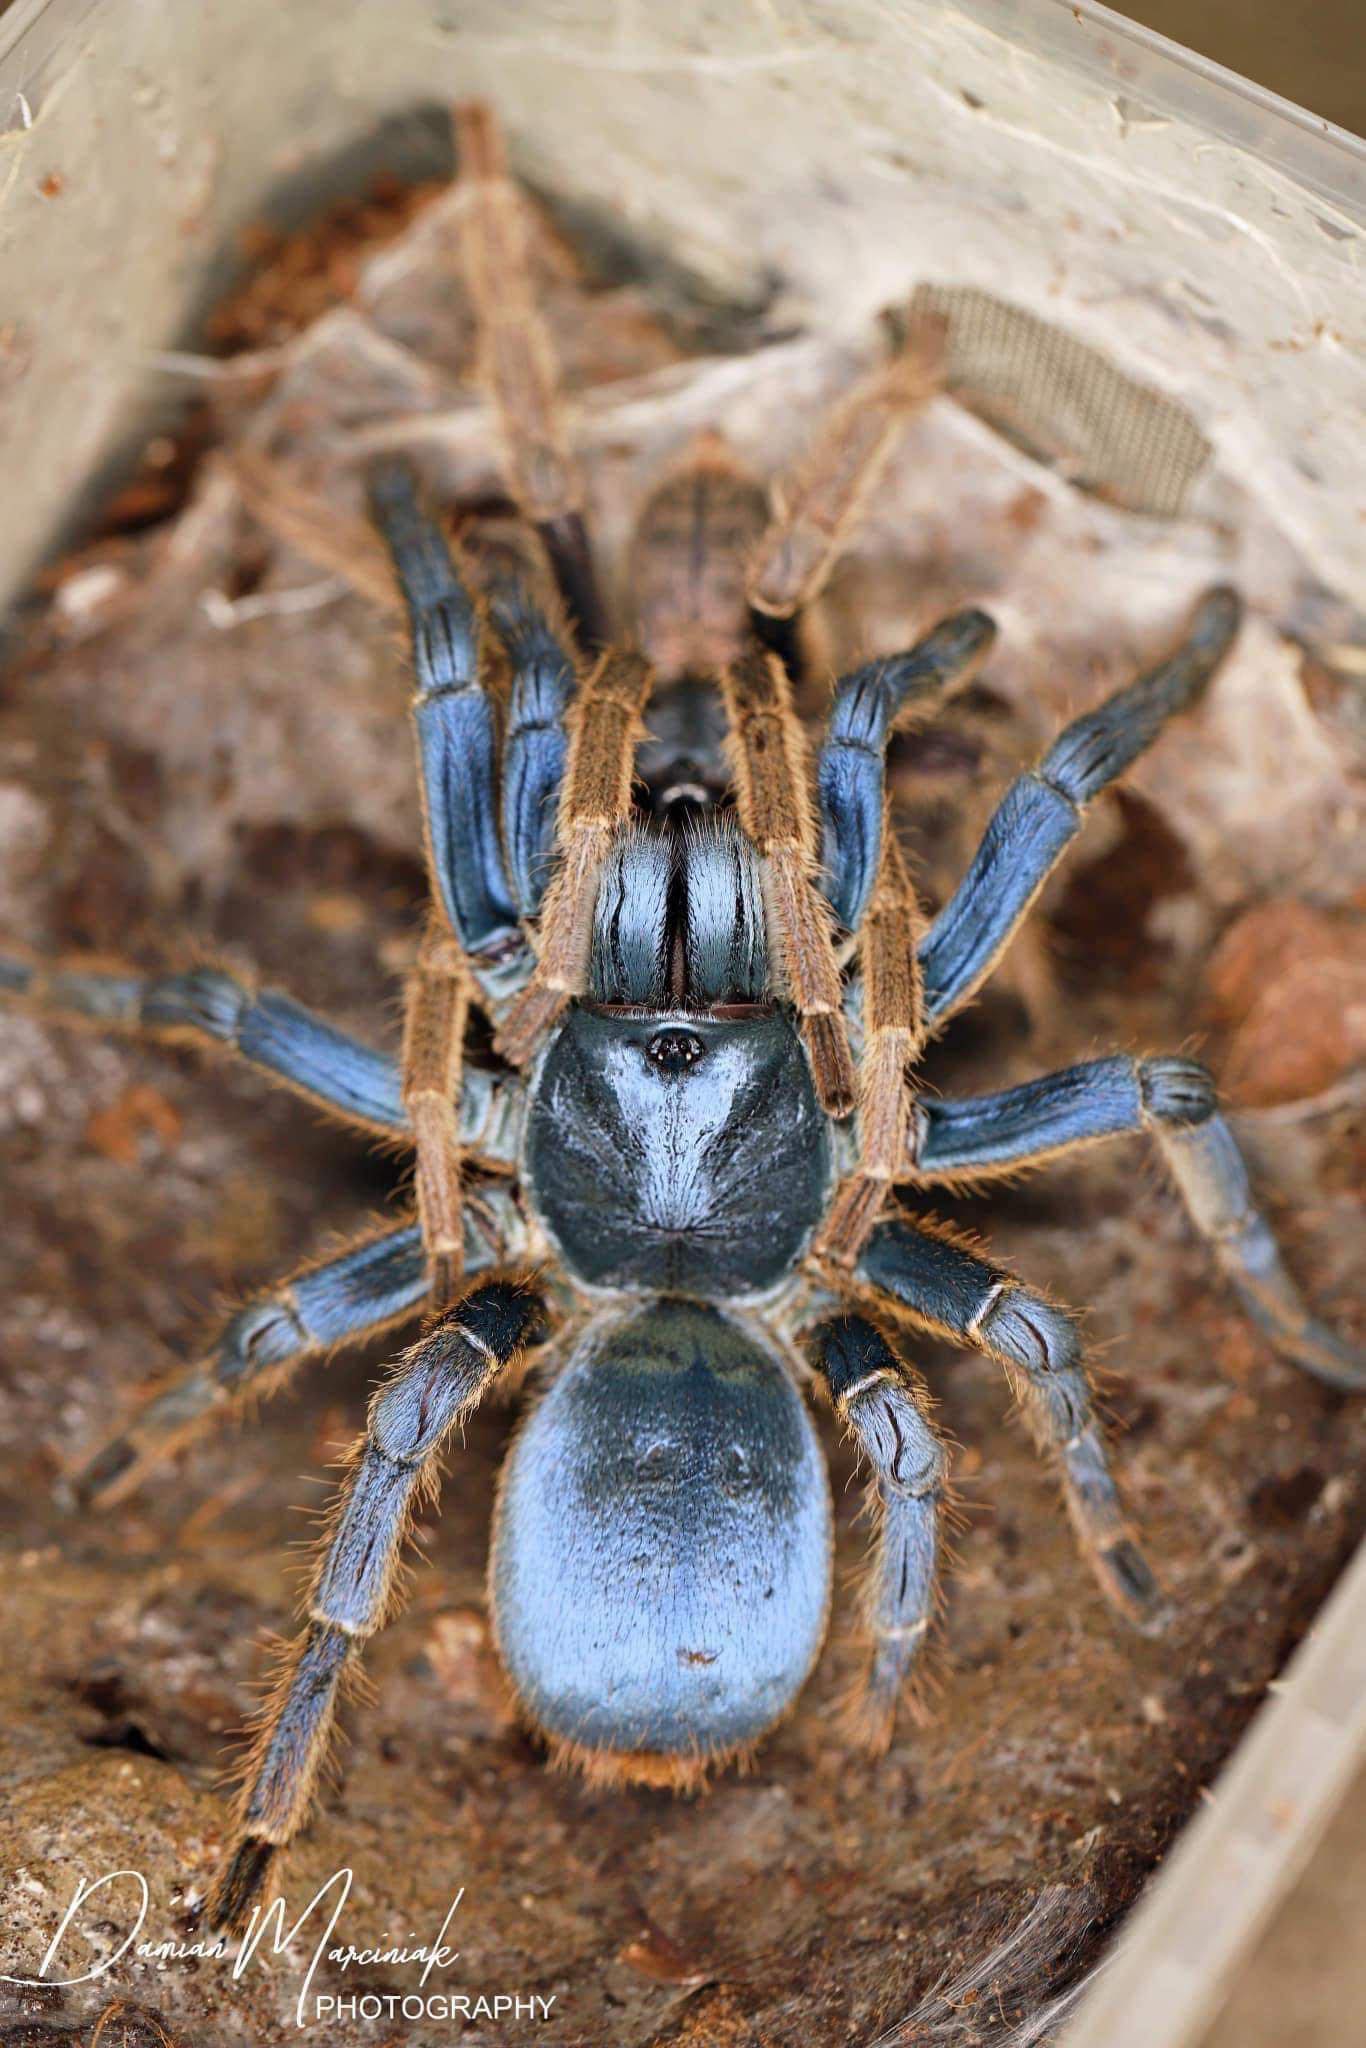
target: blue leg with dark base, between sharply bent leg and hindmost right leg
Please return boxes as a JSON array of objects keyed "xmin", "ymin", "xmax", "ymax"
[{"xmin": 854, "ymin": 1221, "xmax": 1165, "ymax": 1630}]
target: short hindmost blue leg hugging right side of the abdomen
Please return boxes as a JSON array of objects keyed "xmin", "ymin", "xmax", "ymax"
[{"xmin": 811, "ymin": 1315, "xmax": 948, "ymax": 1751}]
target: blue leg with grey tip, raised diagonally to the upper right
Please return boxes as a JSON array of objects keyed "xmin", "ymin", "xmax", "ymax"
[{"xmin": 920, "ymin": 586, "xmax": 1243, "ymax": 1026}]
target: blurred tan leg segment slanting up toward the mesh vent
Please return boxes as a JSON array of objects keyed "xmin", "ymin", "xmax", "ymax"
[{"xmin": 750, "ymin": 322, "xmax": 944, "ymax": 618}]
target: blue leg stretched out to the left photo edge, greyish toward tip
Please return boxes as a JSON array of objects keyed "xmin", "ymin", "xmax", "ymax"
[{"xmin": 0, "ymin": 954, "xmax": 408, "ymax": 1137}]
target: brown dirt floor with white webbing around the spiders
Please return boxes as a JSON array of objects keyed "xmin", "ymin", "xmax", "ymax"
[{"xmin": 0, "ymin": 136, "xmax": 1366, "ymax": 2048}]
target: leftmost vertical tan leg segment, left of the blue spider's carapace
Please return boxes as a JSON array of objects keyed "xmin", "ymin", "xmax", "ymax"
[{"xmin": 403, "ymin": 924, "xmax": 469, "ymax": 1313}]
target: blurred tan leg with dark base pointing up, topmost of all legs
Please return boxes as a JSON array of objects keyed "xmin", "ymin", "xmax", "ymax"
[{"xmin": 455, "ymin": 100, "xmax": 608, "ymax": 651}]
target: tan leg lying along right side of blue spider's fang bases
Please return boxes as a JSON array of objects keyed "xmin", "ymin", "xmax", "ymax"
[{"xmin": 721, "ymin": 651, "xmax": 854, "ymax": 1116}]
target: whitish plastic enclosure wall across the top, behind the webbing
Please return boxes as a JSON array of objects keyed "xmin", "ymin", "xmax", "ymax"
[{"xmin": 0, "ymin": 0, "xmax": 1366, "ymax": 622}]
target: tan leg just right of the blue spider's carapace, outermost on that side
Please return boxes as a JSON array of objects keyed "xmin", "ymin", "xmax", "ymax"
[{"xmin": 815, "ymin": 831, "xmax": 926, "ymax": 1266}]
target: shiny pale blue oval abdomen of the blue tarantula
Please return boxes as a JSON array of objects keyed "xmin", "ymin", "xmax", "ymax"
[{"xmin": 489, "ymin": 1300, "xmax": 831, "ymax": 1784}]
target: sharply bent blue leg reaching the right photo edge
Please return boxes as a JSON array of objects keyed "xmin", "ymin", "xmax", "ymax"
[{"xmin": 913, "ymin": 1057, "xmax": 1366, "ymax": 1386}]
